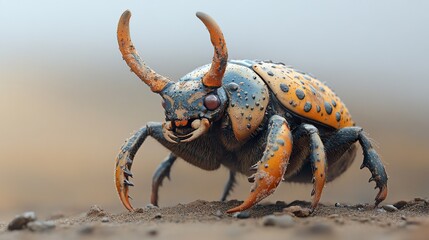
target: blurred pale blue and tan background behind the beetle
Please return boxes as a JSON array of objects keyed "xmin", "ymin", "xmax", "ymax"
[{"xmin": 0, "ymin": 0, "xmax": 429, "ymax": 220}]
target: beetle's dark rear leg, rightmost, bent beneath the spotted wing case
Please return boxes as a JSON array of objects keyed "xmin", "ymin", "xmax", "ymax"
[{"xmin": 325, "ymin": 127, "xmax": 388, "ymax": 206}]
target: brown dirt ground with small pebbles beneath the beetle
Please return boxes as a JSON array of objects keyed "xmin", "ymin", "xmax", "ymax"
[{"xmin": 0, "ymin": 198, "xmax": 429, "ymax": 240}]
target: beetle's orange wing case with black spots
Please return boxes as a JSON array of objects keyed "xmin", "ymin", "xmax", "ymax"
[{"xmin": 252, "ymin": 62, "xmax": 354, "ymax": 129}]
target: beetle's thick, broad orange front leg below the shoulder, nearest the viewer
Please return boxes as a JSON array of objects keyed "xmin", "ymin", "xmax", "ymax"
[{"xmin": 227, "ymin": 115, "xmax": 292, "ymax": 213}]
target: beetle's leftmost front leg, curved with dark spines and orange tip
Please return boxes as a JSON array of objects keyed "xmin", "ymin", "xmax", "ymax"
[{"xmin": 115, "ymin": 126, "xmax": 150, "ymax": 211}]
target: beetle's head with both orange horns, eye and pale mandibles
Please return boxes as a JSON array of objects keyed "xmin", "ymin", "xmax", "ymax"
[{"xmin": 117, "ymin": 10, "xmax": 228, "ymax": 143}]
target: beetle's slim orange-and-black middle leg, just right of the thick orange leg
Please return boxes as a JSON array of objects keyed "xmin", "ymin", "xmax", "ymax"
[{"xmin": 294, "ymin": 124, "xmax": 328, "ymax": 210}]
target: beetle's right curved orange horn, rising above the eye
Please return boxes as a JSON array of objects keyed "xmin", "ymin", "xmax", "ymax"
[{"xmin": 197, "ymin": 12, "xmax": 228, "ymax": 87}]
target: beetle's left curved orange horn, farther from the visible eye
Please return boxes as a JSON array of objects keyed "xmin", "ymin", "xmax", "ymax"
[{"xmin": 117, "ymin": 10, "xmax": 170, "ymax": 93}]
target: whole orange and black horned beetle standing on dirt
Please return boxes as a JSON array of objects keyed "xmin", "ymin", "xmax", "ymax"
[{"xmin": 115, "ymin": 10, "xmax": 388, "ymax": 213}]
